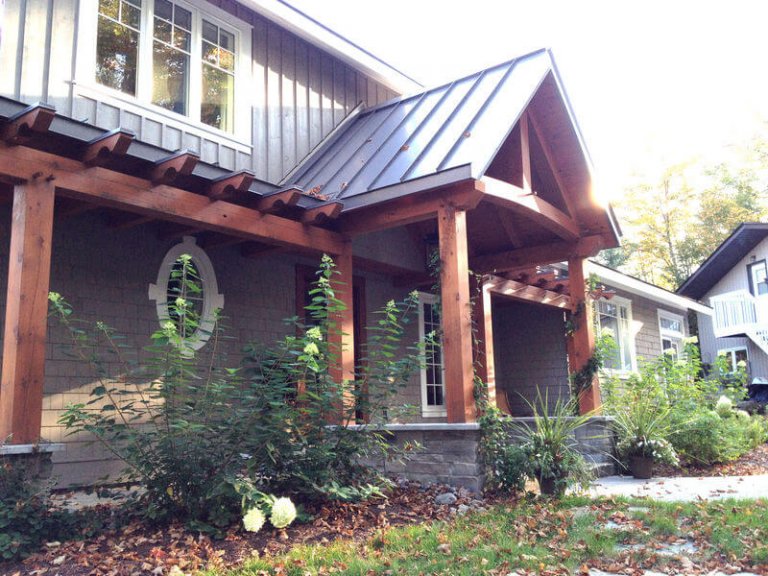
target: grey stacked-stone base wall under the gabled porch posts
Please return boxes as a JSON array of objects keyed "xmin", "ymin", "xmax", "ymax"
[{"xmin": 366, "ymin": 416, "xmax": 615, "ymax": 492}]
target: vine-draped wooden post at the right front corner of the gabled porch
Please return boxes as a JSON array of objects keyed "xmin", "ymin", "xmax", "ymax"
[{"xmin": 568, "ymin": 258, "xmax": 602, "ymax": 414}]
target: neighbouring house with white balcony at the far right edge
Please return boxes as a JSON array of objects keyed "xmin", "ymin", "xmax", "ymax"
[{"xmin": 678, "ymin": 222, "xmax": 768, "ymax": 384}]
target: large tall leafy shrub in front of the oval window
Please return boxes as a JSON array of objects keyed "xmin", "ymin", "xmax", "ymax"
[{"xmin": 51, "ymin": 257, "xmax": 421, "ymax": 531}]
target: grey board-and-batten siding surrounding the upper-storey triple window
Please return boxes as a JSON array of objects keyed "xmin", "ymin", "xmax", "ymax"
[{"xmin": 0, "ymin": 0, "xmax": 397, "ymax": 183}]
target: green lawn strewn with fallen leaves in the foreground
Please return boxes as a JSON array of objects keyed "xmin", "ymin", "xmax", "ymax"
[{"xmin": 202, "ymin": 497, "xmax": 768, "ymax": 576}]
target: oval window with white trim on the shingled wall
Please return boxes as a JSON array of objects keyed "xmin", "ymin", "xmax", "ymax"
[{"xmin": 149, "ymin": 236, "xmax": 224, "ymax": 350}]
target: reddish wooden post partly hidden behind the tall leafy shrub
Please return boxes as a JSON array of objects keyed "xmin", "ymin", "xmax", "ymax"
[{"xmin": 328, "ymin": 242, "xmax": 355, "ymax": 423}]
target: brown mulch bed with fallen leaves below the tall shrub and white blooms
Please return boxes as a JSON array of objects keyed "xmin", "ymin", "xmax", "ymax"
[{"xmin": 0, "ymin": 484, "xmax": 480, "ymax": 576}]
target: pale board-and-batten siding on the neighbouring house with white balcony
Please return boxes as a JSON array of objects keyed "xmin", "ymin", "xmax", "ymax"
[{"xmin": 698, "ymin": 238, "xmax": 768, "ymax": 378}]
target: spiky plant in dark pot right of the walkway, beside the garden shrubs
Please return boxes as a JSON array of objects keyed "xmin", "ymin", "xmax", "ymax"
[{"xmin": 613, "ymin": 398, "xmax": 679, "ymax": 479}]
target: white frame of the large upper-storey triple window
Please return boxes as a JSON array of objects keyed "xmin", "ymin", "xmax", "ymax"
[{"xmin": 73, "ymin": 0, "xmax": 253, "ymax": 146}]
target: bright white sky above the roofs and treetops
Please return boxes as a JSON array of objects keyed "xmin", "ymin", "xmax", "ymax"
[{"xmin": 288, "ymin": 0, "xmax": 768, "ymax": 200}]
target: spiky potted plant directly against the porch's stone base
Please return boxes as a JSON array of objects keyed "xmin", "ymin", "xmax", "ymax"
[{"xmin": 516, "ymin": 394, "xmax": 591, "ymax": 497}]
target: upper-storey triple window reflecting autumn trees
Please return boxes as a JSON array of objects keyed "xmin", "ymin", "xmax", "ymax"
[{"xmin": 86, "ymin": 0, "xmax": 250, "ymax": 139}]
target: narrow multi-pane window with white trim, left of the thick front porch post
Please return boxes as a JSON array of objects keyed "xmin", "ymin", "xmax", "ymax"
[{"xmin": 419, "ymin": 293, "xmax": 446, "ymax": 417}]
